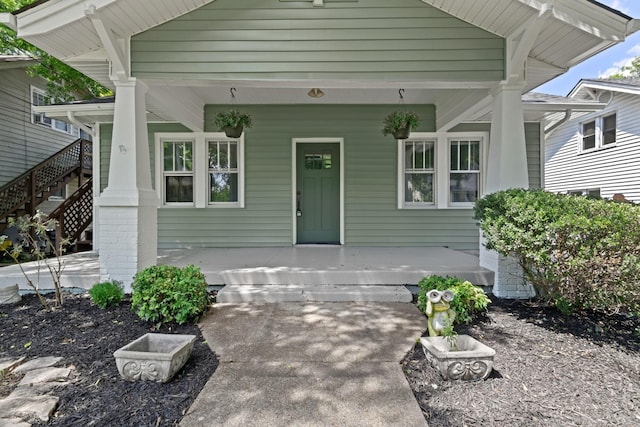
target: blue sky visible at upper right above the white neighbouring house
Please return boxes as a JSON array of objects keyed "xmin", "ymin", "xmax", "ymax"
[{"xmin": 535, "ymin": 0, "xmax": 640, "ymax": 96}]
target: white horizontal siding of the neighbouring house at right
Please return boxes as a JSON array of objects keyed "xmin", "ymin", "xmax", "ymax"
[{"xmin": 545, "ymin": 93, "xmax": 640, "ymax": 202}]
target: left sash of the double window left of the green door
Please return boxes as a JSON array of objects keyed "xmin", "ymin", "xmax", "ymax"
[{"xmin": 162, "ymin": 141, "xmax": 193, "ymax": 203}]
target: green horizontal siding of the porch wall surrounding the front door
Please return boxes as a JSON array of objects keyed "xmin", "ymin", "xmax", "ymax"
[{"xmin": 151, "ymin": 105, "xmax": 478, "ymax": 250}]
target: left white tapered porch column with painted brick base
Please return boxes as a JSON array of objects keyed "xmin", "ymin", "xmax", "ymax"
[{"xmin": 98, "ymin": 78, "xmax": 159, "ymax": 291}]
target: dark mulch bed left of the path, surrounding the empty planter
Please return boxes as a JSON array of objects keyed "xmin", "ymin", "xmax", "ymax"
[{"xmin": 0, "ymin": 295, "xmax": 218, "ymax": 427}]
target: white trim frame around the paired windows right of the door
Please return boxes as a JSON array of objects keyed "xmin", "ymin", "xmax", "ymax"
[{"xmin": 396, "ymin": 132, "xmax": 489, "ymax": 209}]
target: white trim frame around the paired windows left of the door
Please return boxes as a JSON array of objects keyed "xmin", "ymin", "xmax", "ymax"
[{"xmin": 155, "ymin": 132, "xmax": 245, "ymax": 209}]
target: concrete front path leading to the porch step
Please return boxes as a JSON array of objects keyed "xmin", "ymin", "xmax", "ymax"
[{"xmin": 180, "ymin": 303, "xmax": 427, "ymax": 427}]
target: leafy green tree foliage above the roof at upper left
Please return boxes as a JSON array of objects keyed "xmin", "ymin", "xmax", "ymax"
[{"xmin": 0, "ymin": 0, "xmax": 111, "ymax": 103}]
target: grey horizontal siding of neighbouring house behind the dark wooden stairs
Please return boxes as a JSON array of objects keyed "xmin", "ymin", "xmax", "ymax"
[{"xmin": 0, "ymin": 69, "xmax": 76, "ymax": 186}]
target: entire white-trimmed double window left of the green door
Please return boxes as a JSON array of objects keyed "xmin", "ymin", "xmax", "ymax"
[{"xmin": 155, "ymin": 132, "xmax": 244, "ymax": 208}]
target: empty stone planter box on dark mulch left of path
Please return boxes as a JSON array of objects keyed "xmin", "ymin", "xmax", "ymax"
[{"xmin": 113, "ymin": 334, "xmax": 196, "ymax": 383}]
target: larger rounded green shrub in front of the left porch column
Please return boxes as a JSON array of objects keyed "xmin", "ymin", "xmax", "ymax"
[{"xmin": 131, "ymin": 265, "xmax": 209, "ymax": 324}]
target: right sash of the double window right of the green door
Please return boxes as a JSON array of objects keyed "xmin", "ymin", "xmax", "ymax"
[{"xmin": 449, "ymin": 140, "xmax": 480, "ymax": 203}]
